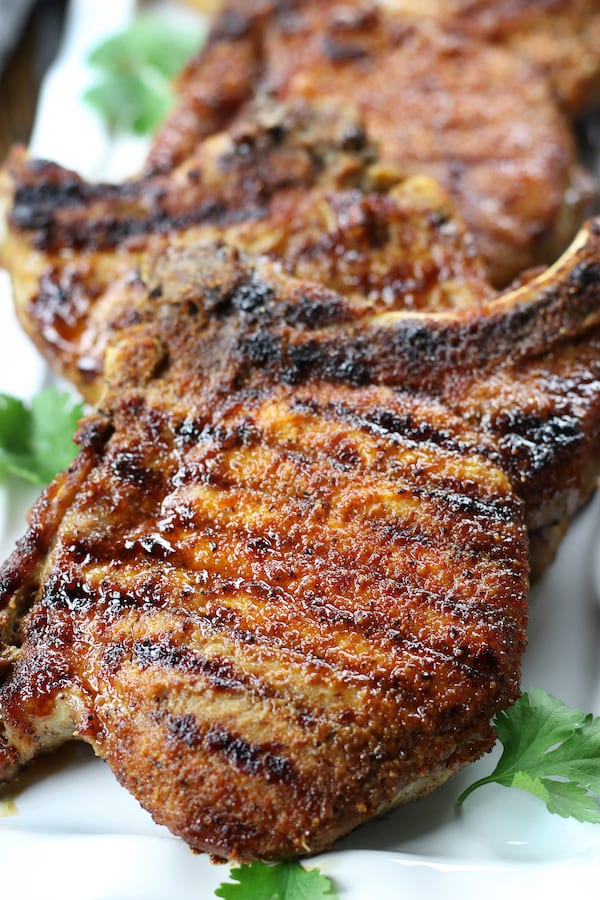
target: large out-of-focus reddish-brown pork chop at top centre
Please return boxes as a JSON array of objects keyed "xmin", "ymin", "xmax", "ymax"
[{"xmin": 150, "ymin": 0, "xmax": 598, "ymax": 285}]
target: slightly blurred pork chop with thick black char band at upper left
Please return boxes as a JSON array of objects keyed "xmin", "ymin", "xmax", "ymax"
[{"xmin": 0, "ymin": 105, "xmax": 492, "ymax": 400}]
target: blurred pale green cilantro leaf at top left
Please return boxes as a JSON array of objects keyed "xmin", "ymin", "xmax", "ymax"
[{"xmin": 83, "ymin": 15, "xmax": 203, "ymax": 134}]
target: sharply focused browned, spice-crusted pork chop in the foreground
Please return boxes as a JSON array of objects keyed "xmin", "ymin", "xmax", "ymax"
[{"xmin": 0, "ymin": 376, "xmax": 527, "ymax": 859}]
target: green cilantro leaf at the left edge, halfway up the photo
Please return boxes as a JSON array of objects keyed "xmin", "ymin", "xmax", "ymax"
[{"xmin": 0, "ymin": 387, "xmax": 83, "ymax": 485}]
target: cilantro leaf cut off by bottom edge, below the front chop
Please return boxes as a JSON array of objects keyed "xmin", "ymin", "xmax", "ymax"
[{"xmin": 215, "ymin": 862, "xmax": 336, "ymax": 900}]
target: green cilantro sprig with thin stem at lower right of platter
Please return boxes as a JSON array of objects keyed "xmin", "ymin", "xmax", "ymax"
[{"xmin": 457, "ymin": 690, "xmax": 600, "ymax": 823}]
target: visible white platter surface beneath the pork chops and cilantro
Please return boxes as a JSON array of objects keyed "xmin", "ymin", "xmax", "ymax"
[{"xmin": 0, "ymin": 0, "xmax": 600, "ymax": 900}]
